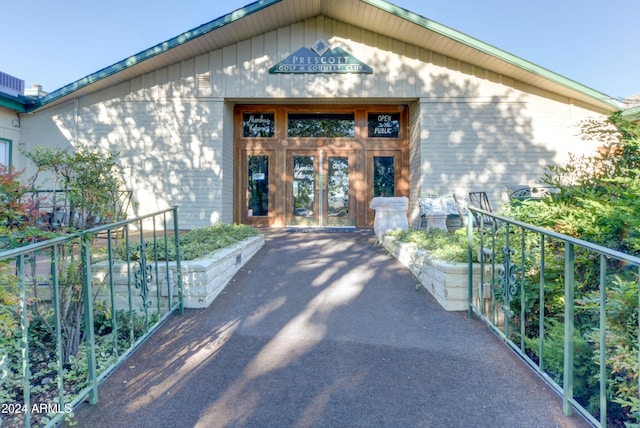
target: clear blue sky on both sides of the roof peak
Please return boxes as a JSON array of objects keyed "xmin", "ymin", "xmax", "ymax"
[{"xmin": 0, "ymin": 0, "xmax": 640, "ymax": 99}]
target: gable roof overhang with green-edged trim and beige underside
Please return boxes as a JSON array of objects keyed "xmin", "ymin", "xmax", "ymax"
[{"xmin": 30, "ymin": 0, "xmax": 623, "ymax": 112}]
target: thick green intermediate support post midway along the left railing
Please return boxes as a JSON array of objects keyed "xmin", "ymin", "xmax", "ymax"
[{"xmin": 81, "ymin": 233, "xmax": 98, "ymax": 404}]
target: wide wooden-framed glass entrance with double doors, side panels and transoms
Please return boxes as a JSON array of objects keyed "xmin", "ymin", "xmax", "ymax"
[{"xmin": 234, "ymin": 106, "xmax": 409, "ymax": 227}]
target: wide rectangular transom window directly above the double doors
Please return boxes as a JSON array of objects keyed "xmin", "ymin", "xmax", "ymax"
[{"xmin": 287, "ymin": 113, "xmax": 356, "ymax": 138}]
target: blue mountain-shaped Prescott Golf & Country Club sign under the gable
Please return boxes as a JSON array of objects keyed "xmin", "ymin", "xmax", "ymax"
[{"xmin": 269, "ymin": 40, "xmax": 373, "ymax": 74}]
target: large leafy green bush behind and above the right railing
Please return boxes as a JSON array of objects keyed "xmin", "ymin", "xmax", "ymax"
[{"xmin": 509, "ymin": 114, "xmax": 640, "ymax": 426}]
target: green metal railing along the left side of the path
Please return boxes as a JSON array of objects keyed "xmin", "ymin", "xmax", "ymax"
[{"xmin": 0, "ymin": 207, "xmax": 183, "ymax": 427}]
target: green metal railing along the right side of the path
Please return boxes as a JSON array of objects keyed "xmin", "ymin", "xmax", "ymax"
[{"xmin": 467, "ymin": 207, "xmax": 640, "ymax": 427}]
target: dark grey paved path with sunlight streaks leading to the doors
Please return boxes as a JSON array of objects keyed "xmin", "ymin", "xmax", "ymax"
[{"xmin": 75, "ymin": 230, "xmax": 588, "ymax": 428}]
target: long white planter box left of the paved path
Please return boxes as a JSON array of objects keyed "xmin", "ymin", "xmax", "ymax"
[{"xmin": 91, "ymin": 235, "xmax": 264, "ymax": 309}]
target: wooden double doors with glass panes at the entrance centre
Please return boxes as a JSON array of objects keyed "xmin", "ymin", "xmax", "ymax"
[{"xmin": 286, "ymin": 149, "xmax": 355, "ymax": 227}]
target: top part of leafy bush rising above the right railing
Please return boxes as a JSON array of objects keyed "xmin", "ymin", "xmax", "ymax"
[{"xmin": 509, "ymin": 114, "xmax": 640, "ymax": 255}]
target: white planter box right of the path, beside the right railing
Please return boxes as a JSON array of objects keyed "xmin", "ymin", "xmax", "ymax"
[{"xmin": 381, "ymin": 236, "xmax": 480, "ymax": 311}]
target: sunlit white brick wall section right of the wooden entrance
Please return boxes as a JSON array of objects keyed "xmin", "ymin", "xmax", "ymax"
[{"xmin": 420, "ymin": 97, "xmax": 595, "ymax": 208}]
